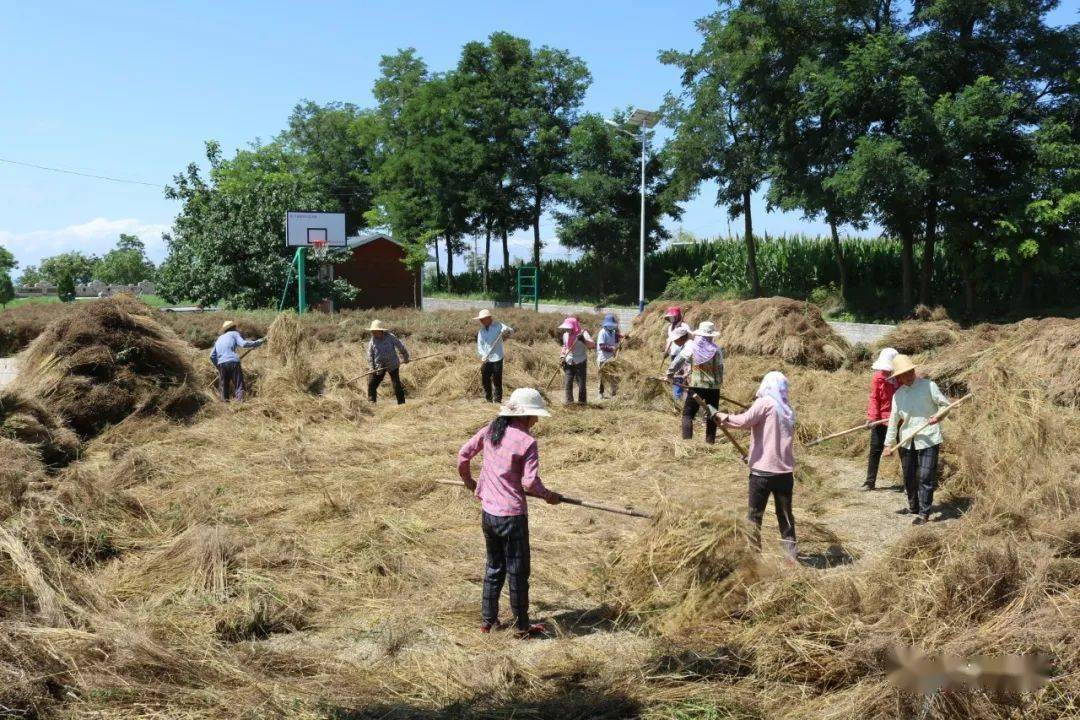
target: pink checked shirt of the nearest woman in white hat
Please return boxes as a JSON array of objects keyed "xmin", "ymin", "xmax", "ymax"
[{"xmin": 458, "ymin": 422, "xmax": 550, "ymax": 517}]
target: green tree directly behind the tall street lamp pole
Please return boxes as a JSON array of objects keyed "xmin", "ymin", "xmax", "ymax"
[{"xmin": 554, "ymin": 112, "xmax": 683, "ymax": 296}]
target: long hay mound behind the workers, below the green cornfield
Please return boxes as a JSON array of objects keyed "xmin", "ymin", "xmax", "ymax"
[{"xmin": 632, "ymin": 297, "xmax": 849, "ymax": 370}]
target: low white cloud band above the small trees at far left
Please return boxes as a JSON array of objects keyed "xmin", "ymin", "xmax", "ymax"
[{"xmin": 0, "ymin": 217, "xmax": 168, "ymax": 268}]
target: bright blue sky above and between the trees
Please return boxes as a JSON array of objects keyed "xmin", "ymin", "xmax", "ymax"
[{"xmin": 0, "ymin": 0, "xmax": 1080, "ymax": 274}]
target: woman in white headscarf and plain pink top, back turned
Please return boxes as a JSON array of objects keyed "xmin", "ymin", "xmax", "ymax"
[{"xmin": 718, "ymin": 371, "xmax": 798, "ymax": 563}]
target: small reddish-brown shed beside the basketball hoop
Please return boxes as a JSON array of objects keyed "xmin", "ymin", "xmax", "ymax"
[{"xmin": 334, "ymin": 232, "xmax": 421, "ymax": 309}]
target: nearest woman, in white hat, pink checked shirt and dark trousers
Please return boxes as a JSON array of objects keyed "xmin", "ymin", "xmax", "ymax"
[{"xmin": 458, "ymin": 388, "xmax": 563, "ymax": 638}]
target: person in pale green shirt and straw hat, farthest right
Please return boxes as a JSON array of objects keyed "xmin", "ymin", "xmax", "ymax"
[{"xmin": 885, "ymin": 355, "xmax": 948, "ymax": 525}]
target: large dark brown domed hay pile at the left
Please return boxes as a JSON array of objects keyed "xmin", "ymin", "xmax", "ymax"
[{"xmin": 16, "ymin": 297, "xmax": 206, "ymax": 438}]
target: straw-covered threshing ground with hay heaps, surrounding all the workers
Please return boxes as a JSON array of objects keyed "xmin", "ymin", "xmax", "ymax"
[{"xmin": 0, "ymin": 301, "xmax": 1080, "ymax": 720}]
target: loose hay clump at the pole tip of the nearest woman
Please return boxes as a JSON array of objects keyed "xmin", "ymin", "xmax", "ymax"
[{"xmin": 603, "ymin": 507, "xmax": 758, "ymax": 631}]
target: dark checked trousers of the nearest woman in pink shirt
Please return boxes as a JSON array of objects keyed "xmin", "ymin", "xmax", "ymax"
[{"xmin": 481, "ymin": 513, "xmax": 530, "ymax": 630}]
